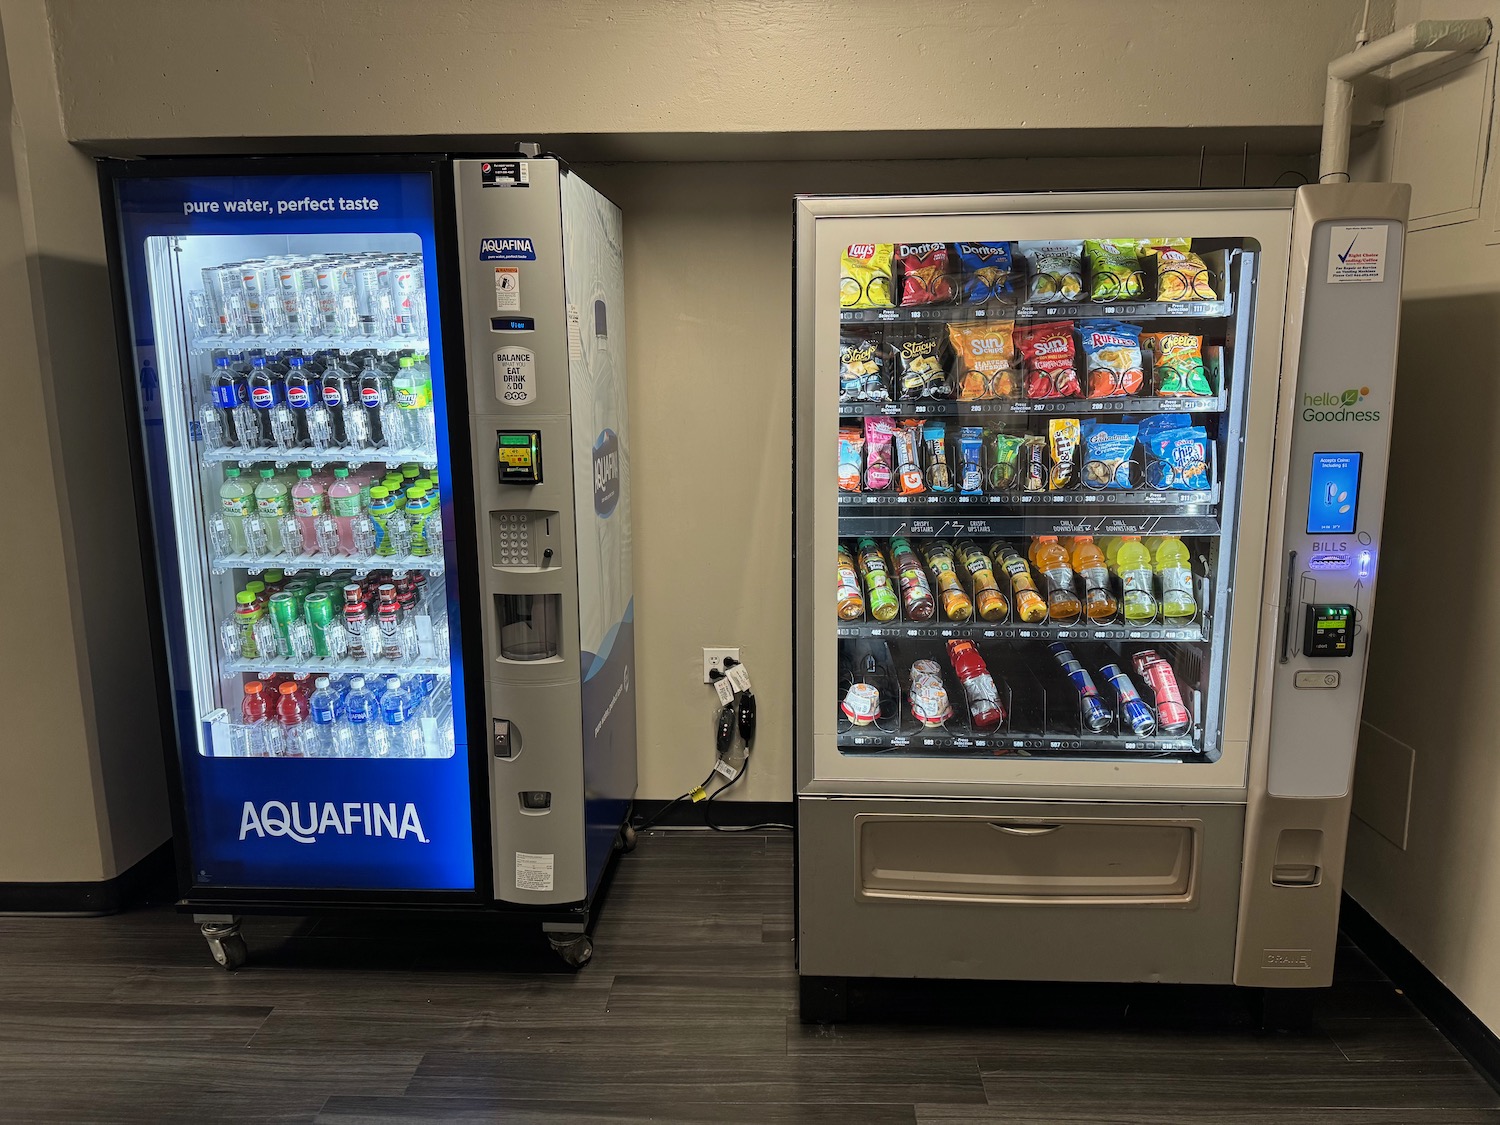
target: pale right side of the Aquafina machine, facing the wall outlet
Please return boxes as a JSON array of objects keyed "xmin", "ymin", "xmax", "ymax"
[{"xmin": 560, "ymin": 168, "xmax": 636, "ymax": 906}]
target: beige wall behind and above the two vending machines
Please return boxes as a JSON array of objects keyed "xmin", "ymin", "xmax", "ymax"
[{"xmin": 0, "ymin": 0, "xmax": 1391, "ymax": 879}]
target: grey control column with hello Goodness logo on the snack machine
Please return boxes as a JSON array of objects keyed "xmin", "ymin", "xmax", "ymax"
[{"xmin": 1235, "ymin": 185, "xmax": 1410, "ymax": 987}]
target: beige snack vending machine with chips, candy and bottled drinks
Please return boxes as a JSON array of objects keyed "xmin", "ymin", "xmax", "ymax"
[{"xmin": 795, "ymin": 185, "xmax": 1409, "ymax": 1019}]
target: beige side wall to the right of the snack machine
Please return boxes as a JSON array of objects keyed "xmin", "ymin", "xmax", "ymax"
[{"xmin": 1346, "ymin": 0, "xmax": 1500, "ymax": 1032}]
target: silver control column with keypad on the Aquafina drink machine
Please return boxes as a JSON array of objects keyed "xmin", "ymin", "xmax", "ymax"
[{"xmin": 455, "ymin": 158, "xmax": 588, "ymax": 906}]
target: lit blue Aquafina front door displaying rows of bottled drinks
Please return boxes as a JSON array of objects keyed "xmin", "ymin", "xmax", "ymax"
[{"xmin": 114, "ymin": 171, "xmax": 476, "ymax": 899}]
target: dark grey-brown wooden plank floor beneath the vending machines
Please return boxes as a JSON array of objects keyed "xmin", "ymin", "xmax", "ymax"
[{"xmin": 0, "ymin": 831, "xmax": 1500, "ymax": 1125}]
